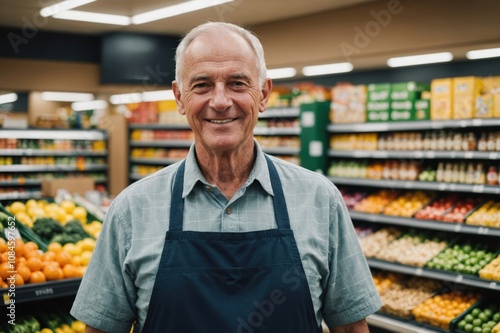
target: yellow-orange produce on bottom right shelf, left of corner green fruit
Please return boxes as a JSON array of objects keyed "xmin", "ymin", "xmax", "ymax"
[{"xmin": 411, "ymin": 290, "xmax": 479, "ymax": 330}]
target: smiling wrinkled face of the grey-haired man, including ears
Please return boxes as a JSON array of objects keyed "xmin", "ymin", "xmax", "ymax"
[{"xmin": 173, "ymin": 33, "xmax": 271, "ymax": 153}]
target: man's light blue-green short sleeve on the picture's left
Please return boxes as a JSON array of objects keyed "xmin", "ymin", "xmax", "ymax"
[{"xmin": 70, "ymin": 198, "xmax": 136, "ymax": 333}]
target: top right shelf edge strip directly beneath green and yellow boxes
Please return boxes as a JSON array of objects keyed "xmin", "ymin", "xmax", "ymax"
[{"xmin": 327, "ymin": 118, "xmax": 500, "ymax": 133}]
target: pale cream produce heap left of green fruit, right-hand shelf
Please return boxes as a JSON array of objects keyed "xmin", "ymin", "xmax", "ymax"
[{"xmin": 374, "ymin": 231, "xmax": 448, "ymax": 267}]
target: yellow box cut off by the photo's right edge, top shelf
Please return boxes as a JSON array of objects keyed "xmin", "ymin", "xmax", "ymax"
[{"xmin": 474, "ymin": 76, "xmax": 500, "ymax": 118}]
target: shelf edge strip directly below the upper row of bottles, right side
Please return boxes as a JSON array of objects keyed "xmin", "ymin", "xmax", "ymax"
[{"xmin": 328, "ymin": 149, "xmax": 500, "ymax": 160}]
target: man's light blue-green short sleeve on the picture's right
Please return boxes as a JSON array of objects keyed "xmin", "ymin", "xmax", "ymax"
[{"xmin": 323, "ymin": 191, "xmax": 382, "ymax": 327}]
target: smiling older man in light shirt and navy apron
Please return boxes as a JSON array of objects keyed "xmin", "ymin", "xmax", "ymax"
[{"xmin": 71, "ymin": 22, "xmax": 381, "ymax": 333}]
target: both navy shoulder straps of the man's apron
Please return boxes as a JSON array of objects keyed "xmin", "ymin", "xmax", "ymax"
[{"xmin": 168, "ymin": 155, "xmax": 290, "ymax": 231}]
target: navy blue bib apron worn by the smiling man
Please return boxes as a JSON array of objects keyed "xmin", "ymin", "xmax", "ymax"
[{"xmin": 143, "ymin": 156, "xmax": 321, "ymax": 333}]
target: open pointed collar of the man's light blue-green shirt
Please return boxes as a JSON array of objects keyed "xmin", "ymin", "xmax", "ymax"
[{"xmin": 182, "ymin": 140, "xmax": 274, "ymax": 198}]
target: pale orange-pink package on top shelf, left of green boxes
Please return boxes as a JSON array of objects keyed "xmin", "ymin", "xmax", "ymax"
[{"xmin": 330, "ymin": 83, "xmax": 366, "ymax": 124}]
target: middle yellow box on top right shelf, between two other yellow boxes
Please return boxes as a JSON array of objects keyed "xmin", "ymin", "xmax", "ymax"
[{"xmin": 453, "ymin": 76, "xmax": 483, "ymax": 119}]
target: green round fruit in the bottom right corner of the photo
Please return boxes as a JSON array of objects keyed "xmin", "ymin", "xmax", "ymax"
[{"xmin": 451, "ymin": 298, "xmax": 500, "ymax": 333}]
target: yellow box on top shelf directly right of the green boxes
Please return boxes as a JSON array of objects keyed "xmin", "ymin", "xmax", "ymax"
[{"xmin": 431, "ymin": 78, "xmax": 453, "ymax": 120}]
